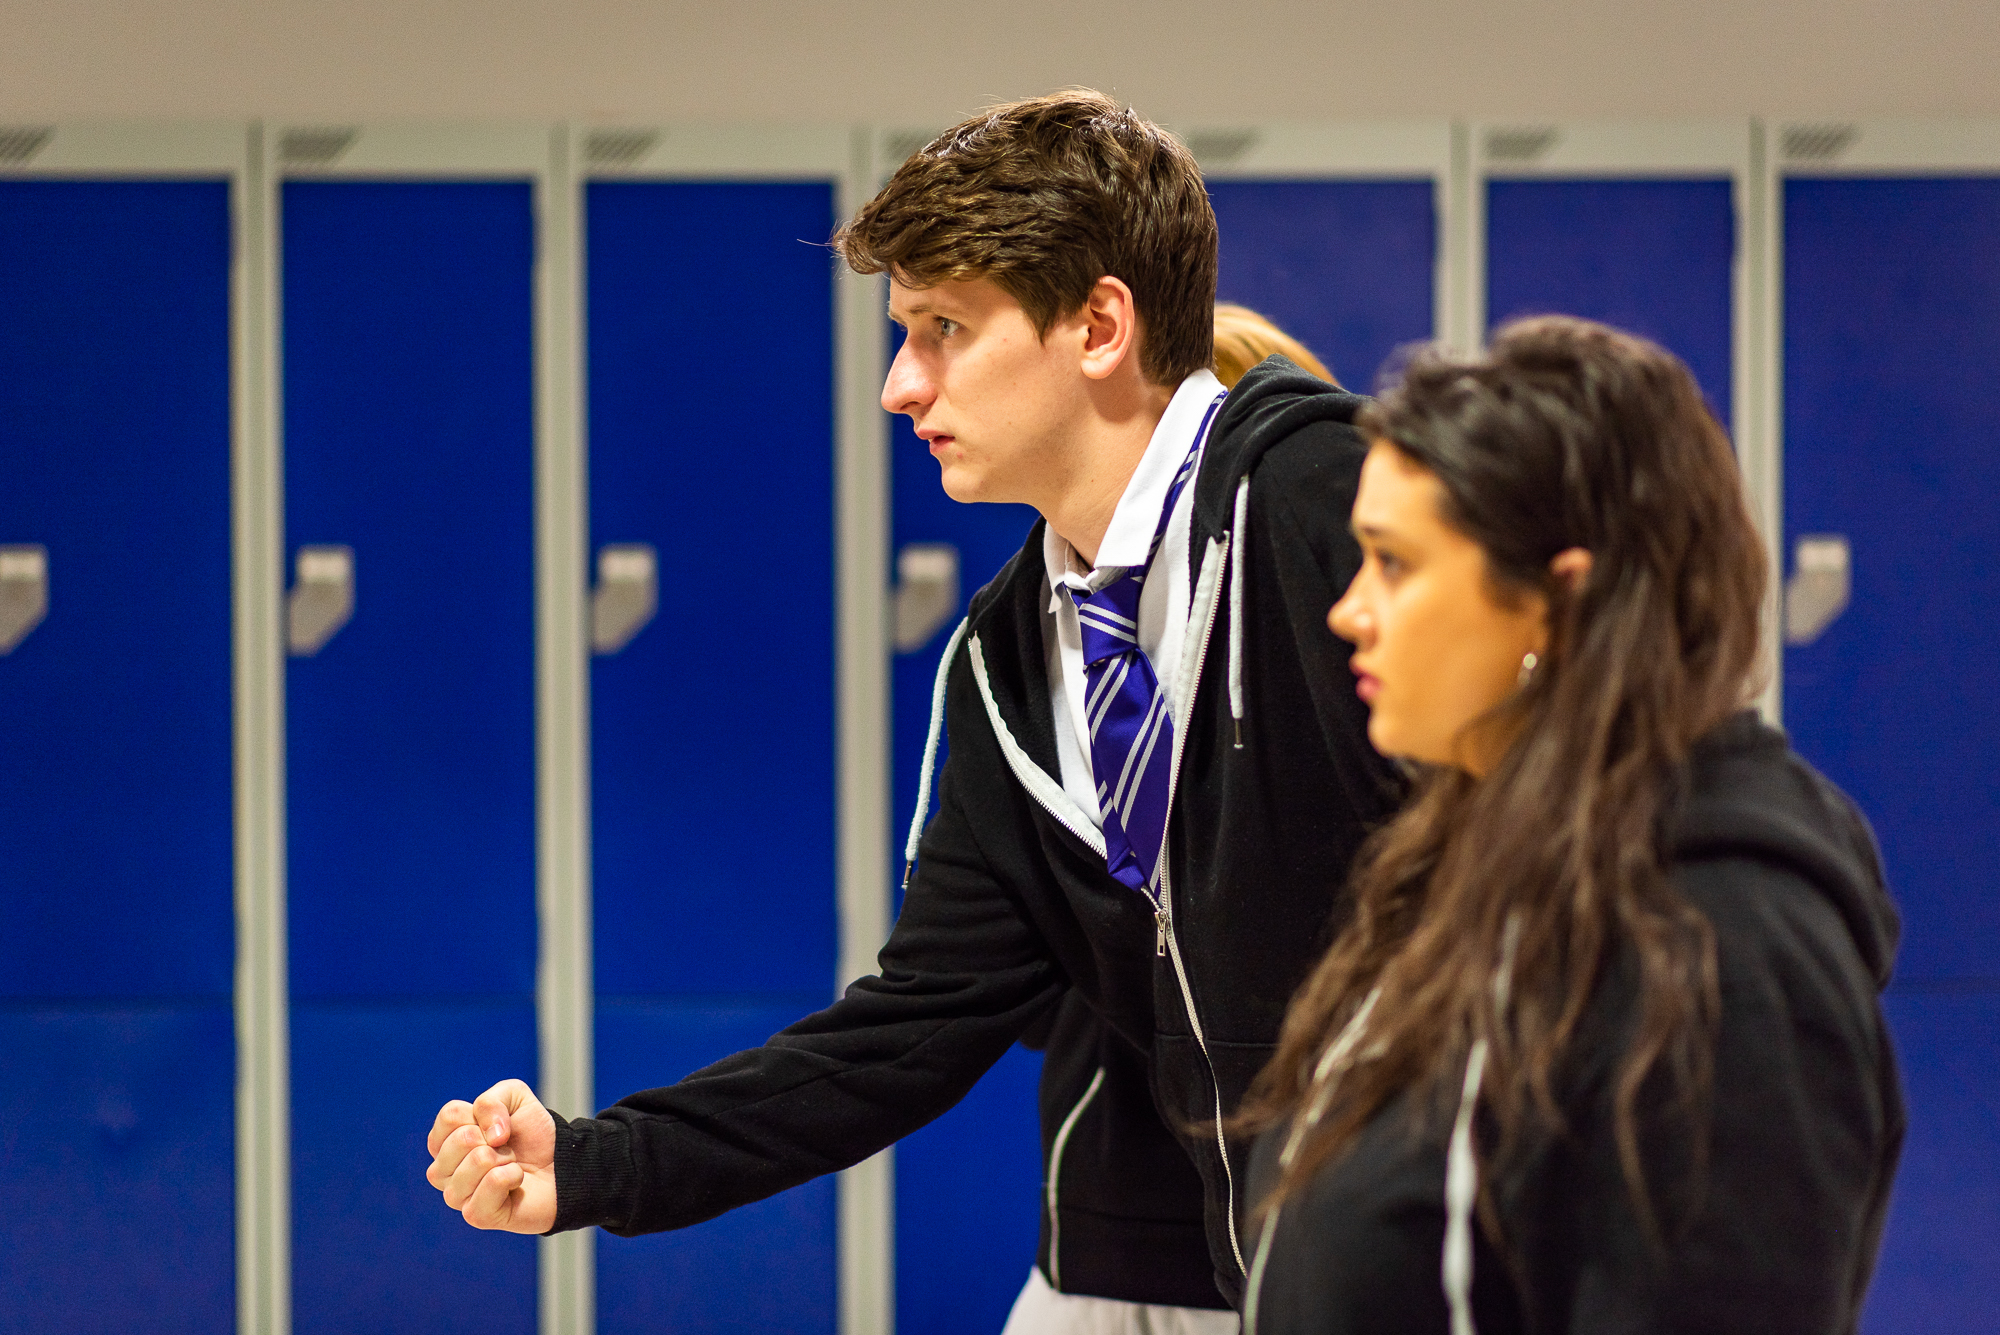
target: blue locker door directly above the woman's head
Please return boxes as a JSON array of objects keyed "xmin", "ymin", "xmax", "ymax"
[{"xmin": 1486, "ymin": 178, "xmax": 1736, "ymax": 426}]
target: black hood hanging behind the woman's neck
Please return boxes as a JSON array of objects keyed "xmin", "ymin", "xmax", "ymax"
[{"xmin": 1670, "ymin": 709, "xmax": 1902, "ymax": 987}]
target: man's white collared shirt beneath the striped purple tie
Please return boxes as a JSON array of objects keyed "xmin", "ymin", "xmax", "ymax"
[{"xmin": 1042, "ymin": 370, "xmax": 1222, "ymax": 829}]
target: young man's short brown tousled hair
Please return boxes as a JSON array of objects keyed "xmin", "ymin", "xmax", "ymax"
[{"xmin": 834, "ymin": 88, "xmax": 1218, "ymax": 386}]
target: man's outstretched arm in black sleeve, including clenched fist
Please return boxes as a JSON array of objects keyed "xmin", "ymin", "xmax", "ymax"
[{"xmin": 426, "ymin": 739, "xmax": 1068, "ymax": 1233}]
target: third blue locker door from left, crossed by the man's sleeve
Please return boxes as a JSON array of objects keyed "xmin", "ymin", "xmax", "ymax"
[{"xmin": 584, "ymin": 182, "xmax": 838, "ymax": 1335}]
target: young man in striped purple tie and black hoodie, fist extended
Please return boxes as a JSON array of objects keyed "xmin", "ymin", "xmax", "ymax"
[{"xmin": 428, "ymin": 92, "xmax": 1398, "ymax": 1331}]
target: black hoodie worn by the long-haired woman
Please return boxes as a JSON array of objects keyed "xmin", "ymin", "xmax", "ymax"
[{"xmin": 1244, "ymin": 713, "xmax": 1904, "ymax": 1335}]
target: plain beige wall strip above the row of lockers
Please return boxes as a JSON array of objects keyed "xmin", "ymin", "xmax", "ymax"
[{"xmin": 0, "ymin": 0, "xmax": 2000, "ymax": 124}]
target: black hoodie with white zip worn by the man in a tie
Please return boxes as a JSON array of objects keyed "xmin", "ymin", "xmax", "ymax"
[{"xmin": 554, "ymin": 360, "xmax": 1400, "ymax": 1301}]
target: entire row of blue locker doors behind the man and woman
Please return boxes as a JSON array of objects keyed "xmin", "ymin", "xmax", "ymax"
[{"xmin": 0, "ymin": 119, "xmax": 2000, "ymax": 1333}]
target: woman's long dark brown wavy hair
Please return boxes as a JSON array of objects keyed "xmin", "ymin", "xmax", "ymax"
[{"xmin": 1234, "ymin": 316, "xmax": 1766, "ymax": 1239}]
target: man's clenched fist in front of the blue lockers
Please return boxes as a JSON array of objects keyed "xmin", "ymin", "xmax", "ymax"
[{"xmin": 424, "ymin": 1079, "xmax": 556, "ymax": 1233}]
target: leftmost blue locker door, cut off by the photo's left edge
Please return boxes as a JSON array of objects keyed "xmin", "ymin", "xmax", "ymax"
[{"xmin": 0, "ymin": 180, "xmax": 236, "ymax": 1335}]
